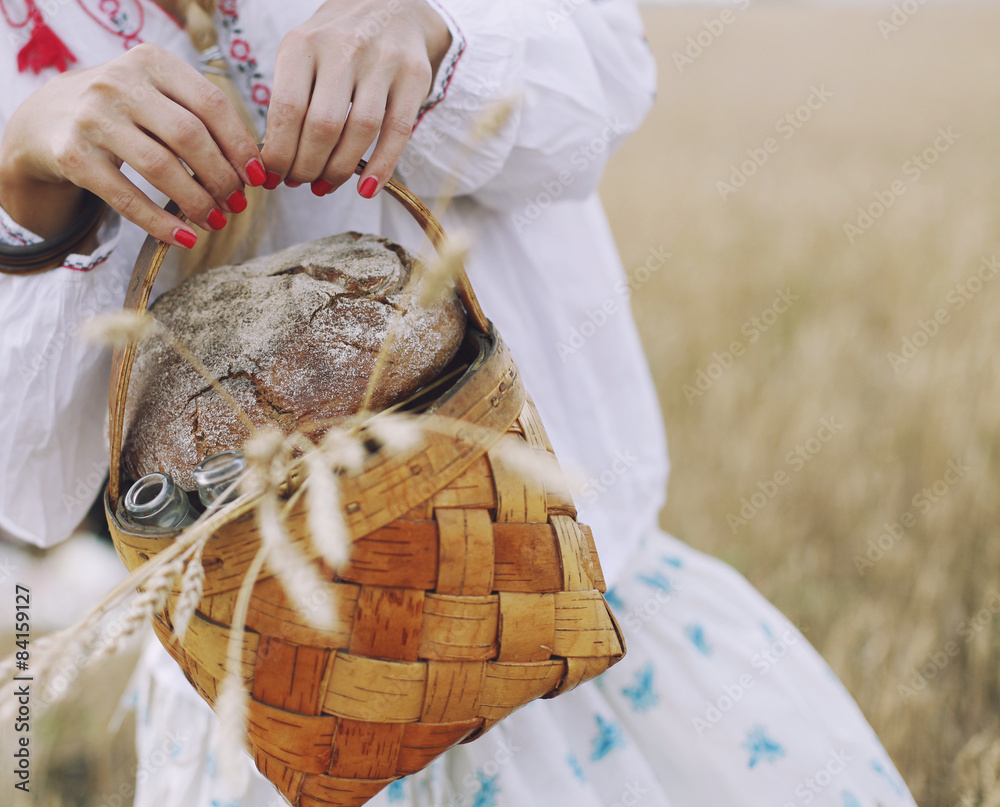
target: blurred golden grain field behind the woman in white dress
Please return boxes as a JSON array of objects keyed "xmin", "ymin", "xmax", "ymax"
[{"xmin": 0, "ymin": 0, "xmax": 1000, "ymax": 807}]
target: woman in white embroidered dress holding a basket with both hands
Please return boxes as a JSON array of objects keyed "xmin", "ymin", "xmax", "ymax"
[{"xmin": 0, "ymin": 0, "xmax": 913, "ymax": 807}]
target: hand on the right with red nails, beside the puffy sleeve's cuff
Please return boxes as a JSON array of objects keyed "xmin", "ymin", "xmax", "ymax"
[{"xmin": 262, "ymin": 0, "xmax": 451, "ymax": 198}]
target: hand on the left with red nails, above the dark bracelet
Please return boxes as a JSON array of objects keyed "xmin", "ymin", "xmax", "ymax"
[{"xmin": 0, "ymin": 44, "xmax": 265, "ymax": 247}]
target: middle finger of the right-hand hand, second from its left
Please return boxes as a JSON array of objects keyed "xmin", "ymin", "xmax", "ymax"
[{"xmin": 289, "ymin": 71, "xmax": 354, "ymax": 188}]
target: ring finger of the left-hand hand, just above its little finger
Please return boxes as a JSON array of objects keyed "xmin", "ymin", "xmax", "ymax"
[{"xmin": 105, "ymin": 127, "xmax": 226, "ymax": 230}]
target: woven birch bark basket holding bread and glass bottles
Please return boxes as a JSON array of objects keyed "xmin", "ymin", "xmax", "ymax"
[{"xmin": 105, "ymin": 170, "xmax": 625, "ymax": 807}]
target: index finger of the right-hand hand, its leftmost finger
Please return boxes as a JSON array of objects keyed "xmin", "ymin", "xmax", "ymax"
[{"xmin": 261, "ymin": 37, "xmax": 316, "ymax": 184}]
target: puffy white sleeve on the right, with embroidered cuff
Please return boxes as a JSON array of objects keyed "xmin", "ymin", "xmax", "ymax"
[{"xmin": 397, "ymin": 0, "xmax": 656, "ymax": 210}]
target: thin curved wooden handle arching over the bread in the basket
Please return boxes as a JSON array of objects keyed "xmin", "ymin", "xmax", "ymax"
[{"xmin": 108, "ymin": 160, "xmax": 490, "ymax": 503}]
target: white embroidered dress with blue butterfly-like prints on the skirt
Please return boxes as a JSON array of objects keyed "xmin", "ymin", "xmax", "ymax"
[{"xmin": 0, "ymin": 0, "xmax": 913, "ymax": 807}]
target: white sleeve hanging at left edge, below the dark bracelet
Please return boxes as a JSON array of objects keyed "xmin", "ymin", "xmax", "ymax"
[{"xmin": 0, "ymin": 201, "xmax": 129, "ymax": 547}]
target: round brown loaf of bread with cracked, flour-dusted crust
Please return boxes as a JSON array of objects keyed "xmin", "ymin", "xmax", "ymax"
[{"xmin": 122, "ymin": 233, "xmax": 465, "ymax": 490}]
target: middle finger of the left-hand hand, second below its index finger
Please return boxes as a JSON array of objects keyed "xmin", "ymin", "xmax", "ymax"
[{"xmin": 135, "ymin": 97, "xmax": 246, "ymax": 213}]
